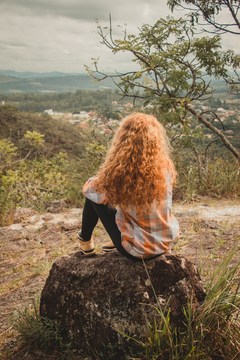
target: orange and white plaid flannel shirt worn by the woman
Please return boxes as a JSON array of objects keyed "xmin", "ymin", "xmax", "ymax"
[{"xmin": 83, "ymin": 175, "xmax": 179, "ymax": 259}]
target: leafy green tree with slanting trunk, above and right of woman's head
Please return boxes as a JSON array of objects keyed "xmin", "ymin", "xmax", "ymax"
[{"xmin": 86, "ymin": 17, "xmax": 239, "ymax": 164}]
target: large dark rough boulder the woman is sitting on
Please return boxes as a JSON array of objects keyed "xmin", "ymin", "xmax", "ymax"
[{"xmin": 40, "ymin": 252, "xmax": 205, "ymax": 359}]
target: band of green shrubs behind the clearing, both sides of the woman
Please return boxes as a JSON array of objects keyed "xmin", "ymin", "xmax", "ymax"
[{"xmin": 0, "ymin": 106, "xmax": 240, "ymax": 226}]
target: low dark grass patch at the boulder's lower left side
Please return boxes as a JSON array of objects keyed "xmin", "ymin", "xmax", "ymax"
[{"xmin": 5, "ymin": 295, "xmax": 115, "ymax": 360}]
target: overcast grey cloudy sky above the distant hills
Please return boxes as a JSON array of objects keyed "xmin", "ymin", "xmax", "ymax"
[{"xmin": 0, "ymin": 0, "xmax": 236, "ymax": 73}]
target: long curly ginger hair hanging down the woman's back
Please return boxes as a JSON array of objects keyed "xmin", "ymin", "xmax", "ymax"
[{"xmin": 94, "ymin": 113, "xmax": 176, "ymax": 211}]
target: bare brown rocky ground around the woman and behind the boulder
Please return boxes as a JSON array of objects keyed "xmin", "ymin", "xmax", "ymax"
[{"xmin": 0, "ymin": 198, "xmax": 240, "ymax": 360}]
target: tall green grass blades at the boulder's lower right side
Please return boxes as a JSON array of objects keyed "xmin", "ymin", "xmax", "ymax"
[{"xmin": 137, "ymin": 243, "xmax": 240, "ymax": 360}]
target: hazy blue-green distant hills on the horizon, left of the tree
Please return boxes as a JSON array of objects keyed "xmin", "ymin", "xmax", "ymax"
[{"xmin": 0, "ymin": 71, "xmax": 115, "ymax": 95}]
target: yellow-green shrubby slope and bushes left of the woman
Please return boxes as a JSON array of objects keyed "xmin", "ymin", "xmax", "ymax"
[{"xmin": 0, "ymin": 106, "xmax": 107, "ymax": 226}]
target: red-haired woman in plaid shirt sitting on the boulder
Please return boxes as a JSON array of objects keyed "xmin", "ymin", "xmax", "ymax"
[{"xmin": 78, "ymin": 113, "xmax": 179, "ymax": 261}]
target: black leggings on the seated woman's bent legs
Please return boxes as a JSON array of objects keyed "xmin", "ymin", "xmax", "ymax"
[{"xmin": 80, "ymin": 198, "xmax": 142, "ymax": 261}]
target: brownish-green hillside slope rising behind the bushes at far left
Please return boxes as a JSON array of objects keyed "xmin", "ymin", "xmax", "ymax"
[{"xmin": 0, "ymin": 106, "xmax": 88, "ymax": 159}]
